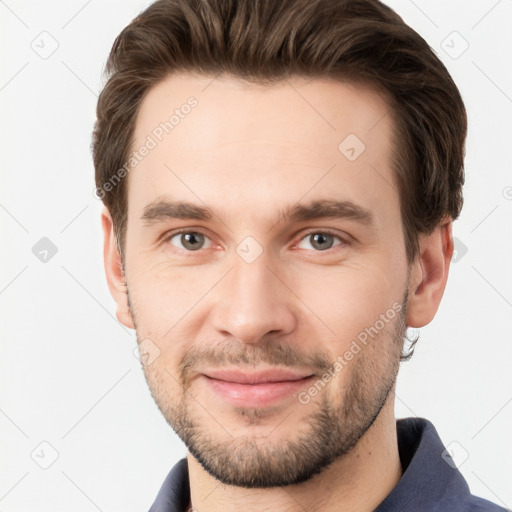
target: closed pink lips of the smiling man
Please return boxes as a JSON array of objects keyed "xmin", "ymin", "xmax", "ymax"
[{"xmin": 201, "ymin": 370, "xmax": 315, "ymax": 408}]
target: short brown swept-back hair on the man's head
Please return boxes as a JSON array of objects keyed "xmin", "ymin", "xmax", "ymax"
[{"xmin": 92, "ymin": 0, "xmax": 467, "ymax": 262}]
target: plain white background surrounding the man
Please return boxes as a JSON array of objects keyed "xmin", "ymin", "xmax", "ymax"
[{"xmin": 0, "ymin": 0, "xmax": 512, "ymax": 512}]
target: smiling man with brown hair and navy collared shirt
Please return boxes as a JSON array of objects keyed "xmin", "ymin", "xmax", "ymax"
[{"xmin": 93, "ymin": 0, "xmax": 503, "ymax": 512}]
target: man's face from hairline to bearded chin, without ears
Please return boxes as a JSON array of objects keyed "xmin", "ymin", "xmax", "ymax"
[{"xmin": 120, "ymin": 74, "xmax": 409, "ymax": 487}]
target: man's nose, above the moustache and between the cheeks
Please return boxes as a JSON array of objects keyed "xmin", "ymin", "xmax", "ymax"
[{"xmin": 213, "ymin": 252, "xmax": 298, "ymax": 344}]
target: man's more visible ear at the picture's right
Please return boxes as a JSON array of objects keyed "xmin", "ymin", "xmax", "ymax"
[{"xmin": 406, "ymin": 218, "xmax": 453, "ymax": 327}]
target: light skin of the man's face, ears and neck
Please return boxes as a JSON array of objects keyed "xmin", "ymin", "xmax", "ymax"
[{"xmin": 102, "ymin": 73, "xmax": 453, "ymax": 512}]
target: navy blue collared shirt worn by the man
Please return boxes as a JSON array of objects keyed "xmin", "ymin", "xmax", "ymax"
[{"xmin": 149, "ymin": 418, "xmax": 507, "ymax": 512}]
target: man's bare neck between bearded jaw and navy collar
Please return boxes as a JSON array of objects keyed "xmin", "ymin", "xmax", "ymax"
[{"xmin": 187, "ymin": 392, "xmax": 402, "ymax": 512}]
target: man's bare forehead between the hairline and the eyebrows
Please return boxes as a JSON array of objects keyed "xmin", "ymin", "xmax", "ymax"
[{"xmin": 128, "ymin": 73, "xmax": 397, "ymax": 228}]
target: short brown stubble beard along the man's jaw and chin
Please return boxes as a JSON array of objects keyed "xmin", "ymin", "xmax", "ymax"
[{"xmin": 132, "ymin": 291, "xmax": 407, "ymax": 488}]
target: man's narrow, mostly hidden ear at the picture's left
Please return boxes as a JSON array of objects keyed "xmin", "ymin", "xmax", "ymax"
[{"xmin": 101, "ymin": 207, "xmax": 134, "ymax": 329}]
